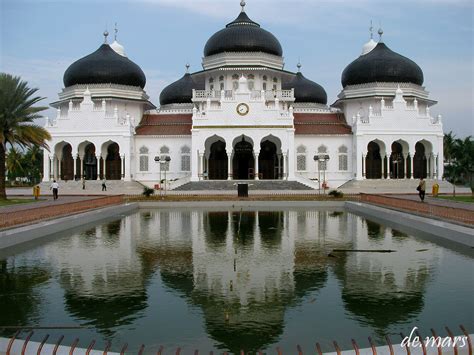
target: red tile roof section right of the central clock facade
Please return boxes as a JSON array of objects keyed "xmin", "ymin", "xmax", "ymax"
[{"xmin": 294, "ymin": 113, "xmax": 352, "ymax": 135}]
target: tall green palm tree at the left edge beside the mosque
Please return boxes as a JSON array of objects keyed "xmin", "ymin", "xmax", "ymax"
[{"xmin": 0, "ymin": 73, "xmax": 51, "ymax": 199}]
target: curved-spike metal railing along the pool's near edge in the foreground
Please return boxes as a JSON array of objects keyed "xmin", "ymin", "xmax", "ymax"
[{"xmin": 0, "ymin": 325, "xmax": 472, "ymax": 355}]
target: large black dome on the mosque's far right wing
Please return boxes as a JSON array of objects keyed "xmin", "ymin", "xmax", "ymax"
[{"xmin": 341, "ymin": 43, "xmax": 423, "ymax": 87}]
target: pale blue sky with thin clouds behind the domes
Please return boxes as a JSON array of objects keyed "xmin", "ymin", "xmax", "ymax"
[{"xmin": 0, "ymin": 0, "xmax": 474, "ymax": 137}]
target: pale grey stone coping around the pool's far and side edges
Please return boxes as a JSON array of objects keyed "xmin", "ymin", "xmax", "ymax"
[{"xmin": 0, "ymin": 200, "xmax": 474, "ymax": 250}]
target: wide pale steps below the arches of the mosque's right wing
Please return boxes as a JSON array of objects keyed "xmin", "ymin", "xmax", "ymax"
[{"xmin": 338, "ymin": 179, "xmax": 453, "ymax": 193}]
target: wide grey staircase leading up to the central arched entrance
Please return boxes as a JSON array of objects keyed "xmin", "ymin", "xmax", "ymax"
[{"xmin": 174, "ymin": 180, "xmax": 312, "ymax": 191}]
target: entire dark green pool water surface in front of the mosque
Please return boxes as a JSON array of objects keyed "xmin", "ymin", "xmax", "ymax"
[{"xmin": 0, "ymin": 209, "xmax": 474, "ymax": 353}]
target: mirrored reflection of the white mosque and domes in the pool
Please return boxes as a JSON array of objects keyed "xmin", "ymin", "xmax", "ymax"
[{"xmin": 33, "ymin": 210, "xmax": 433, "ymax": 350}]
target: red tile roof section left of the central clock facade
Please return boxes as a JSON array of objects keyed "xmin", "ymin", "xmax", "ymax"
[{"xmin": 135, "ymin": 114, "xmax": 193, "ymax": 136}]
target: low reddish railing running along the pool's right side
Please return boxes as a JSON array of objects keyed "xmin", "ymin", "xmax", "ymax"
[{"xmin": 360, "ymin": 194, "xmax": 474, "ymax": 225}]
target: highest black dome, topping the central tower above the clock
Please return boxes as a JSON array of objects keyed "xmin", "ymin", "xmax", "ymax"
[{"xmin": 204, "ymin": 11, "xmax": 283, "ymax": 57}]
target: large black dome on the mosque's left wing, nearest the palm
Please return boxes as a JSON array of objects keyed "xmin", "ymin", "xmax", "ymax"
[{"xmin": 63, "ymin": 44, "xmax": 146, "ymax": 89}]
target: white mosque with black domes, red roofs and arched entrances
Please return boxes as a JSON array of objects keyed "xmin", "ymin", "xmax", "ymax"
[{"xmin": 43, "ymin": 1, "xmax": 443, "ymax": 188}]
